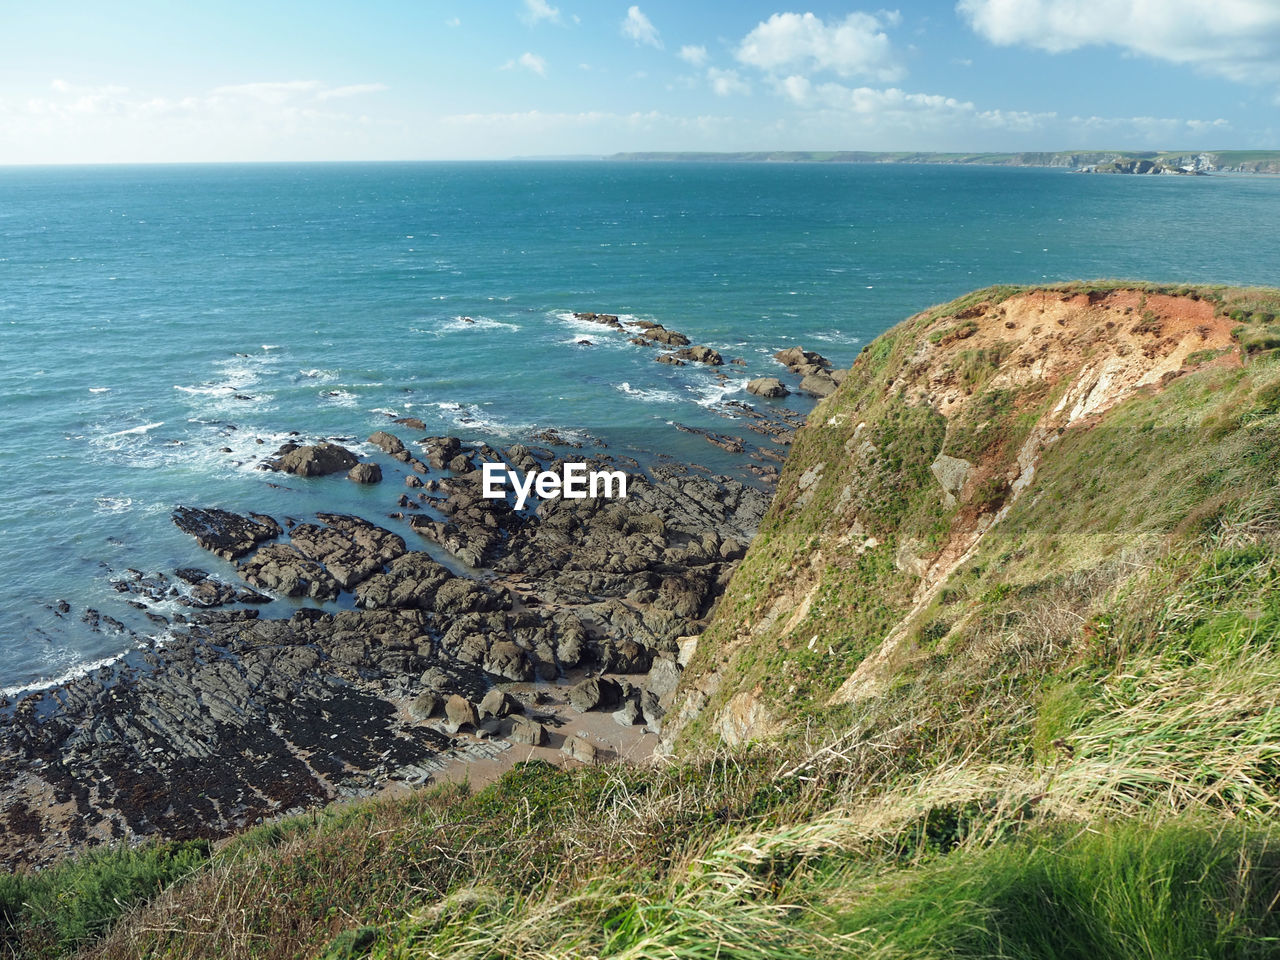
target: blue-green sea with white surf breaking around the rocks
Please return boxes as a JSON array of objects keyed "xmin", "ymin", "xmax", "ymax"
[{"xmin": 0, "ymin": 163, "xmax": 1280, "ymax": 691}]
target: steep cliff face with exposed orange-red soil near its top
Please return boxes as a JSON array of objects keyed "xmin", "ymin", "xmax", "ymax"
[{"xmin": 666, "ymin": 284, "xmax": 1280, "ymax": 750}]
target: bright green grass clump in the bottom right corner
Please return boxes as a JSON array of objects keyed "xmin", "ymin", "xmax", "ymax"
[{"xmin": 836, "ymin": 823, "xmax": 1280, "ymax": 960}]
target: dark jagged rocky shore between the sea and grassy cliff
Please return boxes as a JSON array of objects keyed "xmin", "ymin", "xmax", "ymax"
[{"xmin": 0, "ymin": 314, "xmax": 840, "ymax": 868}]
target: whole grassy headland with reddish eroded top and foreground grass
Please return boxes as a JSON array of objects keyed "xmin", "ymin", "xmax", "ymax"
[{"xmin": 0, "ymin": 283, "xmax": 1280, "ymax": 960}]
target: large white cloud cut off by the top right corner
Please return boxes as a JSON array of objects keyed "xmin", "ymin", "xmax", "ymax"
[{"xmin": 956, "ymin": 0, "xmax": 1280, "ymax": 83}]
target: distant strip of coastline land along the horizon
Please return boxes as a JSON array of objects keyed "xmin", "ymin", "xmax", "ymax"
[{"xmin": 605, "ymin": 150, "xmax": 1280, "ymax": 175}]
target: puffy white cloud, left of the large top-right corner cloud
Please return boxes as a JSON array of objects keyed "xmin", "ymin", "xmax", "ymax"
[{"xmin": 737, "ymin": 12, "xmax": 904, "ymax": 82}]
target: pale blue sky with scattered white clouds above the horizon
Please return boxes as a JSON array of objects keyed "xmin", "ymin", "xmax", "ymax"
[{"xmin": 0, "ymin": 0, "xmax": 1280, "ymax": 164}]
